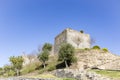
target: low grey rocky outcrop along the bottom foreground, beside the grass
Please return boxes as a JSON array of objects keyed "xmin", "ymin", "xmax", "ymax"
[{"xmin": 55, "ymin": 69, "xmax": 111, "ymax": 80}]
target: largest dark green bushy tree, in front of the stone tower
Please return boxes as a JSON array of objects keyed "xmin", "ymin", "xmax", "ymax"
[{"xmin": 58, "ymin": 43, "xmax": 76, "ymax": 68}]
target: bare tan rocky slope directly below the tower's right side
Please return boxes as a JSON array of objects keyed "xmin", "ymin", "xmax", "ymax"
[{"xmin": 75, "ymin": 49, "xmax": 120, "ymax": 70}]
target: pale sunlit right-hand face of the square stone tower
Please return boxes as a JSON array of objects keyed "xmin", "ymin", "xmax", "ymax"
[{"xmin": 67, "ymin": 29, "xmax": 90, "ymax": 49}]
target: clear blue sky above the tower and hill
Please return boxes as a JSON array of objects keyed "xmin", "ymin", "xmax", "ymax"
[{"xmin": 0, "ymin": 0, "xmax": 120, "ymax": 66}]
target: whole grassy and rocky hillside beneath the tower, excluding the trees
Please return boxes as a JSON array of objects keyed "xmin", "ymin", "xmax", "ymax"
[{"xmin": 0, "ymin": 49, "xmax": 120, "ymax": 80}]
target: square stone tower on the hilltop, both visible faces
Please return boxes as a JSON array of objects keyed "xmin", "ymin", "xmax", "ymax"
[{"xmin": 54, "ymin": 28, "xmax": 90, "ymax": 54}]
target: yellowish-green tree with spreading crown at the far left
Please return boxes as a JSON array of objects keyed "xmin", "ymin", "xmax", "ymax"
[{"xmin": 9, "ymin": 56, "xmax": 24, "ymax": 76}]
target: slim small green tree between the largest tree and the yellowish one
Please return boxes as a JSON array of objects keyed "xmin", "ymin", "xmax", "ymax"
[{"xmin": 38, "ymin": 50, "xmax": 49, "ymax": 68}]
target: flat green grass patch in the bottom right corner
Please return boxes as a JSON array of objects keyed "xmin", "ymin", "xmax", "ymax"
[{"xmin": 90, "ymin": 70, "xmax": 120, "ymax": 78}]
